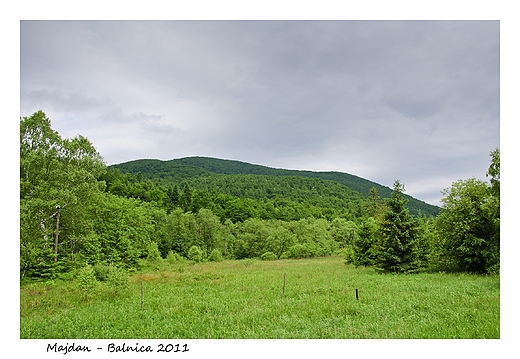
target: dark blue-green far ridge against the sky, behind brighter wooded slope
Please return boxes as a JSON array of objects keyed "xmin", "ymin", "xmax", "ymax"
[{"xmin": 111, "ymin": 157, "xmax": 439, "ymax": 215}]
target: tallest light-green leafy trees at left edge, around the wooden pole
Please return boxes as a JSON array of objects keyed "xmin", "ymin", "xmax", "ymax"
[{"xmin": 20, "ymin": 111, "xmax": 106, "ymax": 276}]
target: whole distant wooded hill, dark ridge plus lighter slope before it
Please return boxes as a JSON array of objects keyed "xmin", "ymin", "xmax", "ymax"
[{"xmin": 110, "ymin": 157, "xmax": 438, "ymax": 222}]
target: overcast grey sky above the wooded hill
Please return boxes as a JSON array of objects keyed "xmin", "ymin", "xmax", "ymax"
[{"xmin": 20, "ymin": 21, "xmax": 500, "ymax": 204}]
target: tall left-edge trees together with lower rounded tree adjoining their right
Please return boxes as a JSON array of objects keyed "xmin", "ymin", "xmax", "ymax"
[{"xmin": 20, "ymin": 111, "xmax": 154, "ymax": 278}]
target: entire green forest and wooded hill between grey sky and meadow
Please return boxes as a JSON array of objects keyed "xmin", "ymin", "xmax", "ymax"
[{"xmin": 20, "ymin": 111, "xmax": 500, "ymax": 279}]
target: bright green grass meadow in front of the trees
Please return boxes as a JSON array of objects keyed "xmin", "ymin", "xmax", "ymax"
[{"xmin": 20, "ymin": 257, "xmax": 500, "ymax": 339}]
